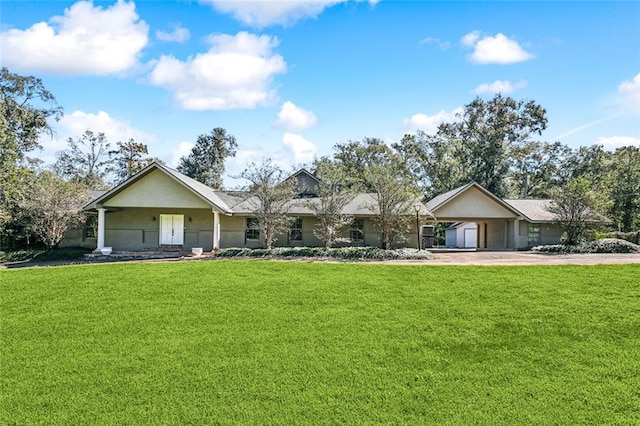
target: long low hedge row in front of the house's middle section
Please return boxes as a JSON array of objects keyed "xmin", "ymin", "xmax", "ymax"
[{"xmin": 216, "ymin": 247, "xmax": 433, "ymax": 260}]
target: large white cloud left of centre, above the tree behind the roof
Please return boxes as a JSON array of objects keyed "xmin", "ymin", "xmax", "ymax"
[{"xmin": 150, "ymin": 32, "xmax": 287, "ymax": 110}]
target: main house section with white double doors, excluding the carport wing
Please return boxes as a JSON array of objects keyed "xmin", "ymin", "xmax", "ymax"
[{"xmin": 61, "ymin": 163, "xmax": 428, "ymax": 251}]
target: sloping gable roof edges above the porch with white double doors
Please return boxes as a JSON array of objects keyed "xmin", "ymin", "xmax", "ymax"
[{"xmin": 83, "ymin": 161, "xmax": 232, "ymax": 214}]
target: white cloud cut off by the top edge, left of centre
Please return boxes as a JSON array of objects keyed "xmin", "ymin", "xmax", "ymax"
[{"xmin": 200, "ymin": 0, "xmax": 378, "ymax": 28}]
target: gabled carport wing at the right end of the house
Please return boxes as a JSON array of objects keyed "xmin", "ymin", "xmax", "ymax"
[{"xmin": 426, "ymin": 182, "xmax": 562, "ymax": 250}]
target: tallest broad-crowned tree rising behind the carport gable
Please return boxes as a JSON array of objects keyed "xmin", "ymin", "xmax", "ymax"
[{"xmin": 438, "ymin": 94, "xmax": 547, "ymax": 197}]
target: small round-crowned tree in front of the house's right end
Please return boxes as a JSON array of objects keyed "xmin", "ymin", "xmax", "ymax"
[{"xmin": 548, "ymin": 178, "xmax": 601, "ymax": 245}]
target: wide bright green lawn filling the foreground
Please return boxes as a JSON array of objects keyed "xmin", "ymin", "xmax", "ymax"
[{"xmin": 0, "ymin": 261, "xmax": 640, "ymax": 425}]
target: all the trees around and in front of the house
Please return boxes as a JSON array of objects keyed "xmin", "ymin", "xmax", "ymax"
[{"xmin": 0, "ymin": 68, "xmax": 640, "ymax": 247}]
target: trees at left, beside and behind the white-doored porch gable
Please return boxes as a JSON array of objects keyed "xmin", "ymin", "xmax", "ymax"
[{"xmin": 0, "ymin": 67, "xmax": 237, "ymax": 249}]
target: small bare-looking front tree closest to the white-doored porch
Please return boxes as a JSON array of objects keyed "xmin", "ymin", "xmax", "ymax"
[{"xmin": 240, "ymin": 160, "xmax": 297, "ymax": 249}]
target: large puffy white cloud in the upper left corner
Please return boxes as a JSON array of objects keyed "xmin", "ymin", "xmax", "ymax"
[{"xmin": 0, "ymin": 0, "xmax": 149, "ymax": 75}]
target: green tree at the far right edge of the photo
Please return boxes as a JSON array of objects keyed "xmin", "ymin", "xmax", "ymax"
[{"xmin": 604, "ymin": 146, "xmax": 640, "ymax": 232}]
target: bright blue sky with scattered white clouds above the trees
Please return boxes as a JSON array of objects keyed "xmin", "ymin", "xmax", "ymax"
[{"xmin": 0, "ymin": 0, "xmax": 640, "ymax": 186}]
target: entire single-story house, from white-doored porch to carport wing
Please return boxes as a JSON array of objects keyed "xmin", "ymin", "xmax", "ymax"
[{"xmin": 60, "ymin": 163, "xmax": 584, "ymax": 251}]
